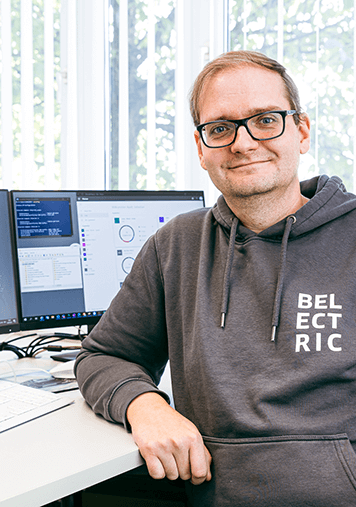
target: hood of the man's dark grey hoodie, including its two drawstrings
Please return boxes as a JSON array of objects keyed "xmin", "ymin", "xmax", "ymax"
[{"xmin": 213, "ymin": 175, "xmax": 356, "ymax": 341}]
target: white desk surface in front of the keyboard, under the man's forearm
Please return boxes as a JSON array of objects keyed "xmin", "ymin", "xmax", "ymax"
[{"xmin": 0, "ymin": 342, "xmax": 143, "ymax": 507}]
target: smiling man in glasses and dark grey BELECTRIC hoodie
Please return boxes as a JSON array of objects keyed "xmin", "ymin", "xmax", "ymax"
[{"xmin": 76, "ymin": 51, "xmax": 356, "ymax": 507}]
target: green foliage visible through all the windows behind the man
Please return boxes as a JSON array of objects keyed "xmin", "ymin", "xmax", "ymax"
[{"xmin": 0, "ymin": 0, "xmax": 355, "ymax": 189}]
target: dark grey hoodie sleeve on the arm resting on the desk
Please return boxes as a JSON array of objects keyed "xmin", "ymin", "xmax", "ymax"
[{"xmin": 75, "ymin": 236, "xmax": 169, "ymax": 428}]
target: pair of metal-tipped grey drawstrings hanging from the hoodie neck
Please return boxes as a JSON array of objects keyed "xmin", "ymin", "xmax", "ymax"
[{"xmin": 220, "ymin": 215, "xmax": 297, "ymax": 341}]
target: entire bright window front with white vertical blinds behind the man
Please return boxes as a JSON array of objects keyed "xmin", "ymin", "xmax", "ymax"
[{"xmin": 0, "ymin": 0, "xmax": 356, "ymax": 195}]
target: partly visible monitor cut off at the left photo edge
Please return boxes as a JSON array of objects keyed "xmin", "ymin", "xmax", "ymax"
[{"xmin": 0, "ymin": 190, "xmax": 20, "ymax": 334}]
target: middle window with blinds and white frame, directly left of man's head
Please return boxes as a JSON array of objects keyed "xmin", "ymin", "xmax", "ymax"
[{"xmin": 107, "ymin": 0, "xmax": 214, "ymax": 202}]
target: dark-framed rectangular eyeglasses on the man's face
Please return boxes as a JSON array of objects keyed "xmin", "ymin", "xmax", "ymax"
[{"xmin": 197, "ymin": 109, "xmax": 297, "ymax": 148}]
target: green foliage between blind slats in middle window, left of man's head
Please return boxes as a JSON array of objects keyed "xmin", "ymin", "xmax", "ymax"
[{"xmin": 110, "ymin": 0, "xmax": 175, "ymax": 189}]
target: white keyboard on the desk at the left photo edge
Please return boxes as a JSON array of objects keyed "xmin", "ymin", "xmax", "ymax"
[{"xmin": 0, "ymin": 380, "xmax": 73, "ymax": 433}]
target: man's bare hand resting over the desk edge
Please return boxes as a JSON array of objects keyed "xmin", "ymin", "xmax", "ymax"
[{"xmin": 127, "ymin": 393, "xmax": 211, "ymax": 485}]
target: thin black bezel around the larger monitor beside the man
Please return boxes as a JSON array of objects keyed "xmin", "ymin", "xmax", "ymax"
[{"xmin": 10, "ymin": 190, "xmax": 205, "ymax": 331}]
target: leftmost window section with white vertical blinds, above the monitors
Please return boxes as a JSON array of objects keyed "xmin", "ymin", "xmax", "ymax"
[{"xmin": 0, "ymin": 0, "xmax": 61, "ymax": 189}]
